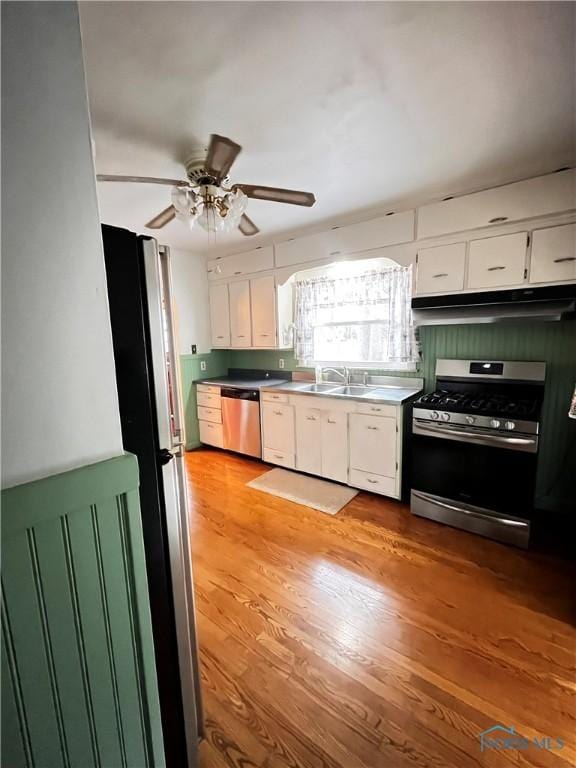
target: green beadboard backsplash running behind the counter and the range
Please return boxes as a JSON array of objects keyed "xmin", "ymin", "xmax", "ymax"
[{"xmin": 182, "ymin": 321, "xmax": 576, "ymax": 514}]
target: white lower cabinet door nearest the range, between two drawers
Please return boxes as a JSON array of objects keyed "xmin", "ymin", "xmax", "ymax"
[{"xmin": 350, "ymin": 413, "xmax": 396, "ymax": 477}]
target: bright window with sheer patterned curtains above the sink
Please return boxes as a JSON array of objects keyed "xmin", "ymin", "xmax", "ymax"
[{"xmin": 295, "ymin": 259, "xmax": 418, "ymax": 370}]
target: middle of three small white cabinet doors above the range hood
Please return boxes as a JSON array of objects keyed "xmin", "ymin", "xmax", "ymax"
[{"xmin": 468, "ymin": 232, "xmax": 528, "ymax": 290}]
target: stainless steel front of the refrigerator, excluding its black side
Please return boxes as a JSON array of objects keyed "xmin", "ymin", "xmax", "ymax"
[{"xmin": 141, "ymin": 238, "xmax": 202, "ymax": 768}]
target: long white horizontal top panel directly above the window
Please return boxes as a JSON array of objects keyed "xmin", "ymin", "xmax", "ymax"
[{"xmin": 276, "ymin": 211, "xmax": 414, "ymax": 267}]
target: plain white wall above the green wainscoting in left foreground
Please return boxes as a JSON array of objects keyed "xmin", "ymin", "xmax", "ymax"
[{"xmin": 2, "ymin": 2, "xmax": 122, "ymax": 487}]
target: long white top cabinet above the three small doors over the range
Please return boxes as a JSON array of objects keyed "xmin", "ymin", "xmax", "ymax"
[{"xmin": 418, "ymin": 169, "xmax": 576, "ymax": 238}]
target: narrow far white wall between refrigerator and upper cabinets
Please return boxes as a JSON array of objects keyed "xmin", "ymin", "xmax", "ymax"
[{"xmin": 170, "ymin": 250, "xmax": 211, "ymax": 355}]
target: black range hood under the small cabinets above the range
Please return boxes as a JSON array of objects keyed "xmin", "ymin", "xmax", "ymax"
[{"xmin": 412, "ymin": 284, "xmax": 576, "ymax": 326}]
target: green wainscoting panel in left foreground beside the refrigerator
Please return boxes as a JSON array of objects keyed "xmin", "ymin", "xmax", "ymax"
[{"xmin": 2, "ymin": 455, "xmax": 164, "ymax": 768}]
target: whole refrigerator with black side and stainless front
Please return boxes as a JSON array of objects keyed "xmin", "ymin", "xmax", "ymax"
[{"xmin": 102, "ymin": 226, "xmax": 202, "ymax": 768}]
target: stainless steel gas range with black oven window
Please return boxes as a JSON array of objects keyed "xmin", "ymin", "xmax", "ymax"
[{"xmin": 410, "ymin": 360, "xmax": 546, "ymax": 547}]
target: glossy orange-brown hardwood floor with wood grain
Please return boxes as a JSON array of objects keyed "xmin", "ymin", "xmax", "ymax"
[{"xmin": 186, "ymin": 449, "xmax": 576, "ymax": 768}]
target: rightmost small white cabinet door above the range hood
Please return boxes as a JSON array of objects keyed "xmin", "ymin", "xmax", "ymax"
[{"xmin": 530, "ymin": 224, "xmax": 576, "ymax": 283}]
